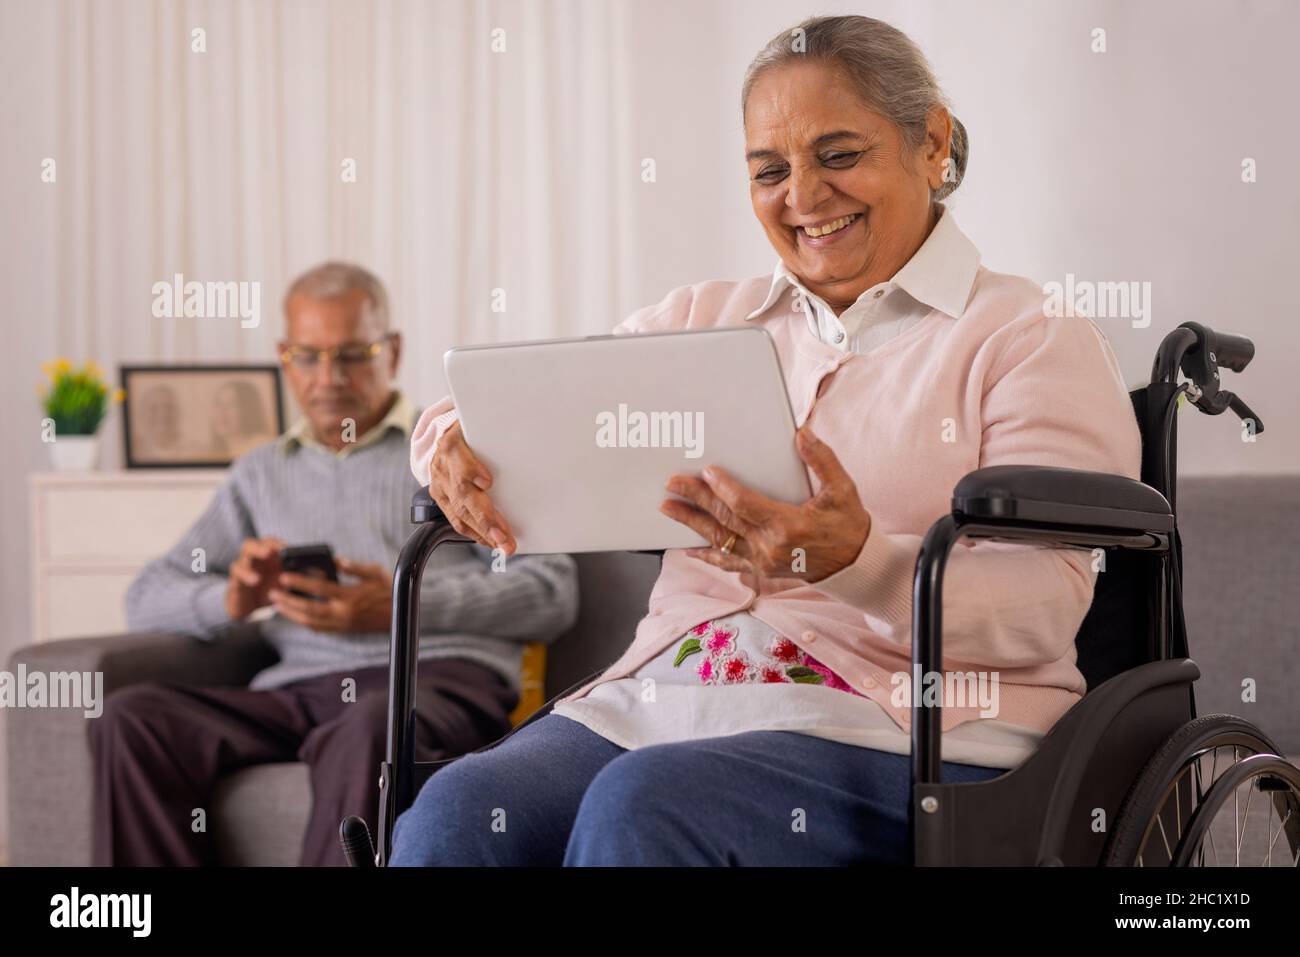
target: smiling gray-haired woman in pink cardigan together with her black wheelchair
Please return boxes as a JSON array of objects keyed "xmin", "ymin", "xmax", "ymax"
[{"xmin": 369, "ymin": 17, "xmax": 1300, "ymax": 865}]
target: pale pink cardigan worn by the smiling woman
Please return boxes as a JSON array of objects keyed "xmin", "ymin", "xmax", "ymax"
[{"xmin": 411, "ymin": 267, "xmax": 1140, "ymax": 731}]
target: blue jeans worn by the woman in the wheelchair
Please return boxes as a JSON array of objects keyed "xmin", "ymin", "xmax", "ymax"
[{"xmin": 391, "ymin": 714, "xmax": 1004, "ymax": 867}]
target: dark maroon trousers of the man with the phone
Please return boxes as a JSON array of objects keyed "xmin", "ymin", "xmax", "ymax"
[{"xmin": 90, "ymin": 659, "xmax": 517, "ymax": 866}]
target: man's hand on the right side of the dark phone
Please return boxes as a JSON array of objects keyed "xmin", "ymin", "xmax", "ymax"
[{"xmin": 268, "ymin": 558, "xmax": 393, "ymax": 632}]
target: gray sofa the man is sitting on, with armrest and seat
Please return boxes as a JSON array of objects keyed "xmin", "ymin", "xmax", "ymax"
[{"xmin": 7, "ymin": 546, "xmax": 659, "ymax": 866}]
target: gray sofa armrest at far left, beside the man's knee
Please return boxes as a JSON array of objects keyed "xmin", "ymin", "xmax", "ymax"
[{"xmin": 4, "ymin": 627, "xmax": 276, "ymax": 866}]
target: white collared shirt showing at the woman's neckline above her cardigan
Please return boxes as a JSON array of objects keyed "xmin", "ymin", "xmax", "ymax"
[{"xmin": 745, "ymin": 203, "xmax": 979, "ymax": 354}]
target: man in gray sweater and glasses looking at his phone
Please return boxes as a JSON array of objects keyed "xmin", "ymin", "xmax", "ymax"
[{"xmin": 90, "ymin": 263, "xmax": 577, "ymax": 865}]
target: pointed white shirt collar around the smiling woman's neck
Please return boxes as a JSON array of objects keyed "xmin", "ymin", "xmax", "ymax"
[{"xmin": 745, "ymin": 203, "xmax": 980, "ymax": 327}]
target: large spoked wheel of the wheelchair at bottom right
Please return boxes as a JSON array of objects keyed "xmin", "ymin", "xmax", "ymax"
[{"xmin": 1104, "ymin": 714, "xmax": 1300, "ymax": 867}]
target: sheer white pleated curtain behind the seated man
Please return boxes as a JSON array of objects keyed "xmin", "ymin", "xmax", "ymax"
[{"xmin": 38, "ymin": 0, "xmax": 650, "ymax": 400}]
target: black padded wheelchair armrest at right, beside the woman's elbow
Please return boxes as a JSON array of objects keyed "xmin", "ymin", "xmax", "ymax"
[{"xmin": 953, "ymin": 465, "xmax": 1174, "ymax": 532}]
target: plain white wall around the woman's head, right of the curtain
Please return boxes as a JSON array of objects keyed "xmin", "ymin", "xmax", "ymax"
[{"xmin": 618, "ymin": 0, "xmax": 1300, "ymax": 473}]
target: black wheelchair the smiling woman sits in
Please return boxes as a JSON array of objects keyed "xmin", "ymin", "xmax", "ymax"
[{"xmin": 341, "ymin": 322, "xmax": 1300, "ymax": 867}]
